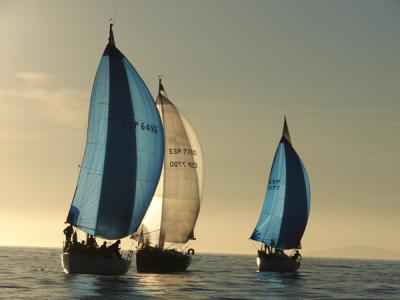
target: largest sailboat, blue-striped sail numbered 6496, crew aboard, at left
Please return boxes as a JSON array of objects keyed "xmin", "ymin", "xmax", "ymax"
[{"xmin": 61, "ymin": 22, "xmax": 164, "ymax": 275}]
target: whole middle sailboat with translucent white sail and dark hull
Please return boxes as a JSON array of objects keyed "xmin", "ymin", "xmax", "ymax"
[{"xmin": 133, "ymin": 78, "xmax": 203, "ymax": 273}]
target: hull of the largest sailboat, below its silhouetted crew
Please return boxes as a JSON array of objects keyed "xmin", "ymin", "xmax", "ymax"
[{"xmin": 61, "ymin": 253, "xmax": 131, "ymax": 275}]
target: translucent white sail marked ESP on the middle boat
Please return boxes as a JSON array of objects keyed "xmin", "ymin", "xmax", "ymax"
[{"xmin": 140, "ymin": 80, "xmax": 203, "ymax": 248}]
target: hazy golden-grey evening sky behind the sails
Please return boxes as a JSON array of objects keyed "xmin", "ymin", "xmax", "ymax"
[{"xmin": 0, "ymin": 0, "xmax": 400, "ymax": 254}]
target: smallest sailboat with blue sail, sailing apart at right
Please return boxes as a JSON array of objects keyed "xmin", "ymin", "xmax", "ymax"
[{"xmin": 251, "ymin": 117, "xmax": 310, "ymax": 272}]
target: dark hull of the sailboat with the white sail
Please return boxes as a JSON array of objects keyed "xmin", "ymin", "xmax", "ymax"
[{"xmin": 136, "ymin": 247, "xmax": 192, "ymax": 273}]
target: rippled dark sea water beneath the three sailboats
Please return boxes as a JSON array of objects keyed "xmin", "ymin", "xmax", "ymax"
[{"xmin": 0, "ymin": 247, "xmax": 400, "ymax": 299}]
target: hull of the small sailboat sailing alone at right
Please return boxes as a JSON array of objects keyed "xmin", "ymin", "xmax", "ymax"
[{"xmin": 257, "ymin": 252, "xmax": 301, "ymax": 272}]
